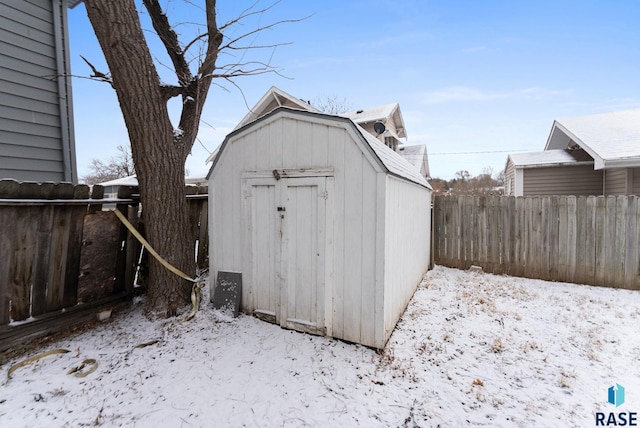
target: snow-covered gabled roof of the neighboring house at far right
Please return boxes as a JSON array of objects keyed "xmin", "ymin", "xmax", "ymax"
[{"xmin": 546, "ymin": 109, "xmax": 640, "ymax": 169}]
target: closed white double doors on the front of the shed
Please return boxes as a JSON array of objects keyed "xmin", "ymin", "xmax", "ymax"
[{"xmin": 244, "ymin": 177, "xmax": 328, "ymax": 334}]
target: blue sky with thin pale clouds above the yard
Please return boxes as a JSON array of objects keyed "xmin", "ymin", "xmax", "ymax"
[{"xmin": 69, "ymin": 0, "xmax": 640, "ymax": 179}]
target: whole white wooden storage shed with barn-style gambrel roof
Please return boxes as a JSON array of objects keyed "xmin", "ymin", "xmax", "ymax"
[{"xmin": 207, "ymin": 107, "xmax": 431, "ymax": 348}]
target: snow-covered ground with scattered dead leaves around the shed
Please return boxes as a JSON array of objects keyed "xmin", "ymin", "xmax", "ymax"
[{"xmin": 0, "ymin": 267, "xmax": 640, "ymax": 427}]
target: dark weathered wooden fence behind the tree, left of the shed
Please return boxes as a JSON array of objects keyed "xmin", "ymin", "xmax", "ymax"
[{"xmin": 0, "ymin": 180, "xmax": 208, "ymax": 351}]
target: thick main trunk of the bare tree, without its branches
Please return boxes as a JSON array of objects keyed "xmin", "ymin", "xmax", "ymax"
[{"xmin": 85, "ymin": 0, "xmax": 195, "ymax": 316}]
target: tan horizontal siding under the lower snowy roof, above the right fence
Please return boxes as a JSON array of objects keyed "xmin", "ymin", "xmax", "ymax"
[{"xmin": 523, "ymin": 165, "xmax": 603, "ymax": 196}]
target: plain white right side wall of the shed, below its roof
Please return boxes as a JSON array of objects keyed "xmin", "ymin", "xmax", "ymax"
[{"xmin": 384, "ymin": 176, "xmax": 431, "ymax": 341}]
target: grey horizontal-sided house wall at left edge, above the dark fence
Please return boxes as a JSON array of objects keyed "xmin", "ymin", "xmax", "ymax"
[{"xmin": 0, "ymin": 0, "xmax": 77, "ymax": 183}]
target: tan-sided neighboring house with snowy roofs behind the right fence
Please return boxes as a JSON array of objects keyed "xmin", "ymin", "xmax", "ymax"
[{"xmin": 505, "ymin": 109, "xmax": 640, "ymax": 196}]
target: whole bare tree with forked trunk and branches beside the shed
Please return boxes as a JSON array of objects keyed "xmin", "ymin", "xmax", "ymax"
[{"xmin": 83, "ymin": 0, "xmax": 288, "ymax": 316}]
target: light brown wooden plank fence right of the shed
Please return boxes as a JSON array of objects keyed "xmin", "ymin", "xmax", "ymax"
[{"xmin": 433, "ymin": 196, "xmax": 640, "ymax": 290}]
